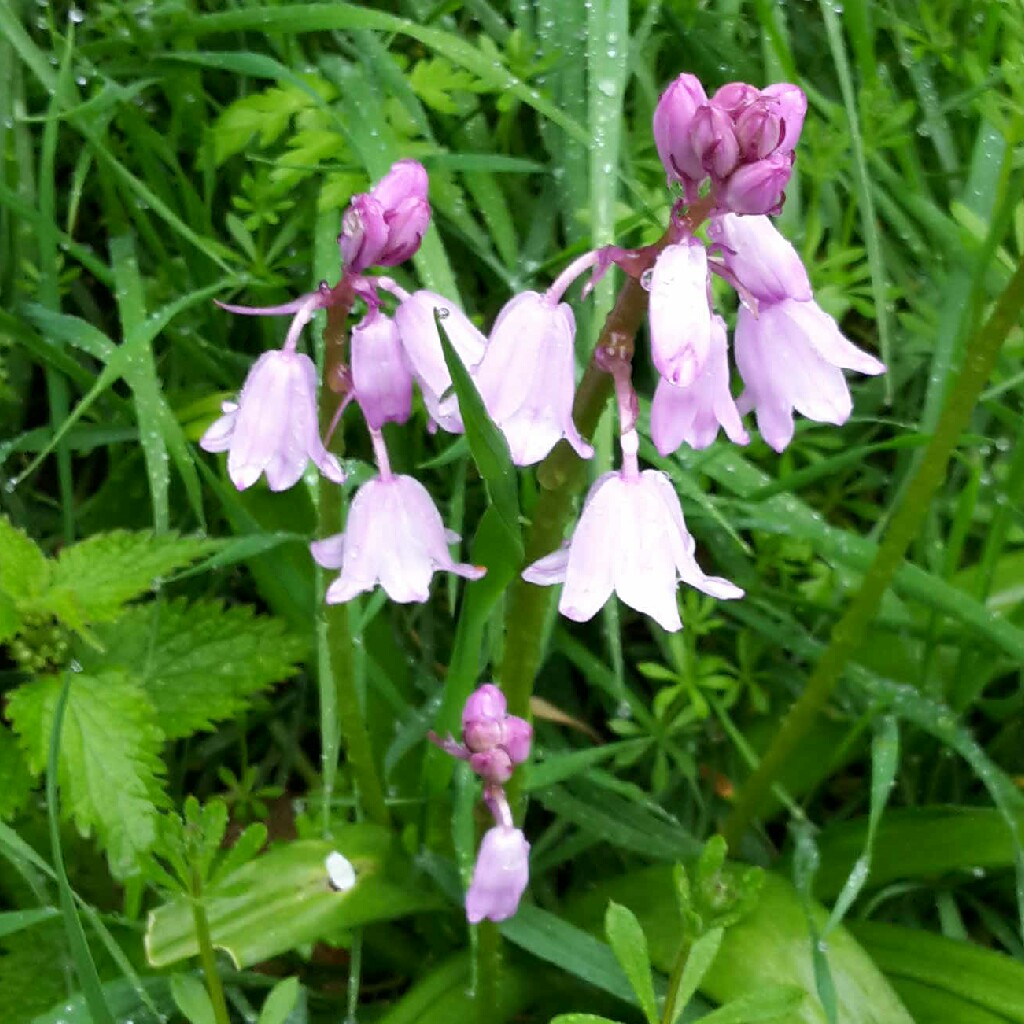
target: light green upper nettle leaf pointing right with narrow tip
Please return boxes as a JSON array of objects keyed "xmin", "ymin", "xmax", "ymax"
[{"xmin": 37, "ymin": 529, "xmax": 218, "ymax": 629}]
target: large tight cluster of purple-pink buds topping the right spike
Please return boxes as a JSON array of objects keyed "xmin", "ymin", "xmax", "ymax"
[{"xmin": 654, "ymin": 75, "xmax": 807, "ymax": 214}]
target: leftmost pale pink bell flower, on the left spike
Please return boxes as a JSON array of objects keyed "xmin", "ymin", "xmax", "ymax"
[{"xmin": 199, "ymin": 348, "xmax": 345, "ymax": 490}]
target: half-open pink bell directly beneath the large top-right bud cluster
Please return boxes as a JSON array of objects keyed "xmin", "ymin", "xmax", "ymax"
[{"xmin": 708, "ymin": 213, "xmax": 812, "ymax": 302}]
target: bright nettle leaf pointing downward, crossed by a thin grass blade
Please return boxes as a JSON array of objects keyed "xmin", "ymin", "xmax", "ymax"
[{"xmin": 7, "ymin": 672, "xmax": 165, "ymax": 878}]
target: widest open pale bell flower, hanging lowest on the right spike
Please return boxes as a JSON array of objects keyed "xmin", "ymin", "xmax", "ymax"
[{"xmin": 522, "ymin": 469, "xmax": 743, "ymax": 632}]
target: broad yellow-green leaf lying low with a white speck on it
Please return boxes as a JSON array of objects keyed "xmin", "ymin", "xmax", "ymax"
[{"xmin": 145, "ymin": 825, "xmax": 438, "ymax": 970}]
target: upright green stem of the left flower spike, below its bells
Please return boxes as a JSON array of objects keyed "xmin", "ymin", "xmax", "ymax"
[{"xmin": 316, "ymin": 299, "xmax": 389, "ymax": 833}]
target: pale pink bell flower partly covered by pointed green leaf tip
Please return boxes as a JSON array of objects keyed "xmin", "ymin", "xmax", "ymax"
[{"xmin": 394, "ymin": 291, "xmax": 487, "ymax": 433}]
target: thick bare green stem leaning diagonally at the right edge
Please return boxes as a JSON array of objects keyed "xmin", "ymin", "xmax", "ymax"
[{"xmin": 722, "ymin": 263, "xmax": 1024, "ymax": 850}]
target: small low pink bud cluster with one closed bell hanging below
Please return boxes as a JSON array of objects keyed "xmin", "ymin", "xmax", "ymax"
[{"xmin": 430, "ymin": 683, "xmax": 534, "ymax": 925}]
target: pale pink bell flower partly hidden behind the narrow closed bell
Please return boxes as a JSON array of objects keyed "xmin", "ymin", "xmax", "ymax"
[{"xmin": 650, "ymin": 316, "xmax": 750, "ymax": 456}]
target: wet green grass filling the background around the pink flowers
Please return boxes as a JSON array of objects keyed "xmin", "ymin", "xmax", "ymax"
[{"xmin": 0, "ymin": 0, "xmax": 1024, "ymax": 1024}]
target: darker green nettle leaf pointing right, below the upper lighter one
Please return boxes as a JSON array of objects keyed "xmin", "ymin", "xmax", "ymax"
[{"xmin": 90, "ymin": 599, "xmax": 307, "ymax": 739}]
